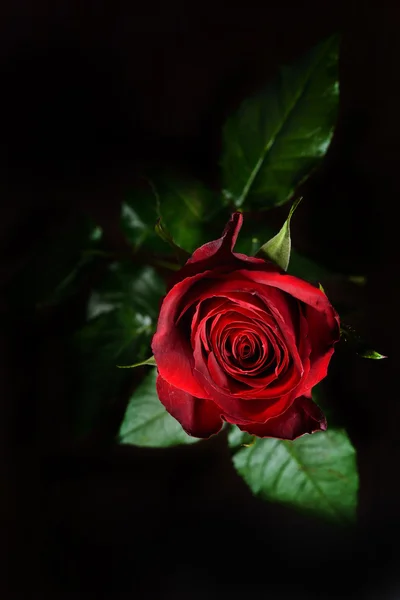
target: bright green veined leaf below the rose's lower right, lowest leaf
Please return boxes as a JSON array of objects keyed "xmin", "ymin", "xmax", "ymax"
[{"xmin": 229, "ymin": 428, "xmax": 358, "ymax": 524}]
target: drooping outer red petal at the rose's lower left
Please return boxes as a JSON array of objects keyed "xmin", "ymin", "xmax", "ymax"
[{"xmin": 157, "ymin": 375, "xmax": 223, "ymax": 438}]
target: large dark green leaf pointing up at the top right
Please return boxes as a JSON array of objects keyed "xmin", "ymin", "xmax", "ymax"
[{"xmin": 221, "ymin": 36, "xmax": 339, "ymax": 208}]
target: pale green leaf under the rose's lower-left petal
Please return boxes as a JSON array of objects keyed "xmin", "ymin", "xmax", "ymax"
[{"xmin": 118, "ymin": 369, "xmax": 199, "ymax": 448}]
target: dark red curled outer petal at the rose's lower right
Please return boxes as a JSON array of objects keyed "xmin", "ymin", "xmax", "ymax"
[{"xmin": 238, "ymin": 396, "xmax": 327, "ymax": 440}]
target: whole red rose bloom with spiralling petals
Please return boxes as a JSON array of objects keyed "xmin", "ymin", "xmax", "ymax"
[{"xmin": 152, "ymin": 213, "xmax": 339, "ymax": 440}]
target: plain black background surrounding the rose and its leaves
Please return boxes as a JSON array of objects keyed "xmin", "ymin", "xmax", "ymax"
[{"xmin": 0, "ymin": 0, "xmax": 400, "ymax": 599}]
